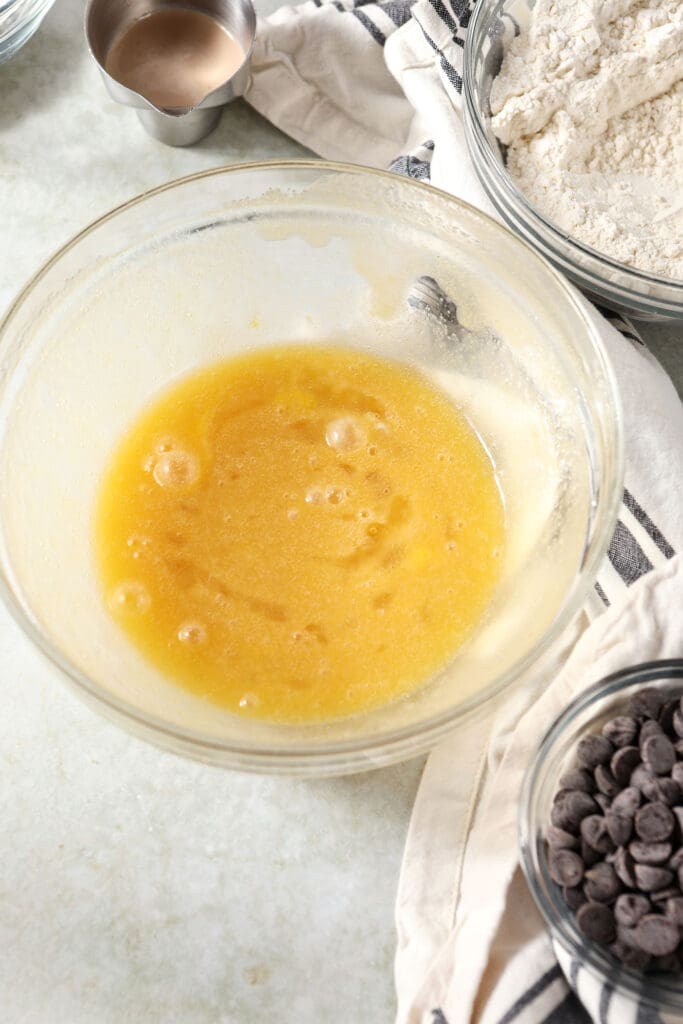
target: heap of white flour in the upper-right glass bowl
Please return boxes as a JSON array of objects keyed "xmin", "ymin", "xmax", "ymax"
[{"xmin": 490, "ymin": 0, "xmax": 683, "ymax": 280}]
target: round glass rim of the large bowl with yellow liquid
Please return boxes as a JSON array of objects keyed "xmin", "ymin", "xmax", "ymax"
[{"xmin": 0, "ymin": 160, "xmax": 624, "ymax": 774}]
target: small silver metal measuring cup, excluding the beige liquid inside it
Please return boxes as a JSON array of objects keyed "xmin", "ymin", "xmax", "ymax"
[{"xmin": 85, "ymin": 0, "xmax": 256, "ymax": 145}]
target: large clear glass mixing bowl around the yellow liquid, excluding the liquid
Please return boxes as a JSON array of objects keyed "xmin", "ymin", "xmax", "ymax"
[{"xmin": 0, "ymin": 162, "xmax": 623, "ymax": 774}]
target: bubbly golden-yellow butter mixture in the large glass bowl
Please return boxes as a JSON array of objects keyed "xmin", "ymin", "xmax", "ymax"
[{"xmin": 96, "ymin": 345, "xmax": 504, "ymax": 722}]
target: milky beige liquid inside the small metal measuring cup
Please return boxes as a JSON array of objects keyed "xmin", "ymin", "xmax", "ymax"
[{"xmin": 105, "ymin": 7, "xmax": 245, "ymax": 111}]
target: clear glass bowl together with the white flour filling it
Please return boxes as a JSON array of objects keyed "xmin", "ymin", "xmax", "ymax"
[{"xmin": 464, "ymin": 0, "xmax": 683, "ymax": 319}]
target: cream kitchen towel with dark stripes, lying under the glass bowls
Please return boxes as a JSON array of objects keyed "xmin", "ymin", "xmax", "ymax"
[{"xmin": 246, "ymin": 0, "xmax": 683, "ymax": 1024}]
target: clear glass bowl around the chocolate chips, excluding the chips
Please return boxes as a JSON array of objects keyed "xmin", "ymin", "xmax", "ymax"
[{"xmin": 519, "ymin": 658, "xmax": 683, "ymax": 1022}]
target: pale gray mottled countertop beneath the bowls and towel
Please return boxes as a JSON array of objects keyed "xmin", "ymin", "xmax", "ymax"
[{"xmin": 0, "ymin": 0, "xmax": 683, "ymax": 1024}]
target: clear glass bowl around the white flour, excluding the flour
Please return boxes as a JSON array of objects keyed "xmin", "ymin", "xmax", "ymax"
[{"xmin": 463, "ymin": 0, "xmax": 683, "ymax": 321}]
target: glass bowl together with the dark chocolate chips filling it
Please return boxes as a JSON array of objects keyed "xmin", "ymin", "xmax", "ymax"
[{"xmin": 519, "ymin": 658, "xmax": 683, "ymax": 1021}]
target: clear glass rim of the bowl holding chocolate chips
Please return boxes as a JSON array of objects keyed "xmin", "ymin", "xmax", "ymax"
[{"xmin": 517, "ymin": 657, "xmax": 683, "ymax": 1010}]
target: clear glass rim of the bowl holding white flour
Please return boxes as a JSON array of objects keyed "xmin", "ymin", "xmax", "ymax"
[{"xmin": 463, "ymin": 0, "xmax": 683, "ymax": 317}]
